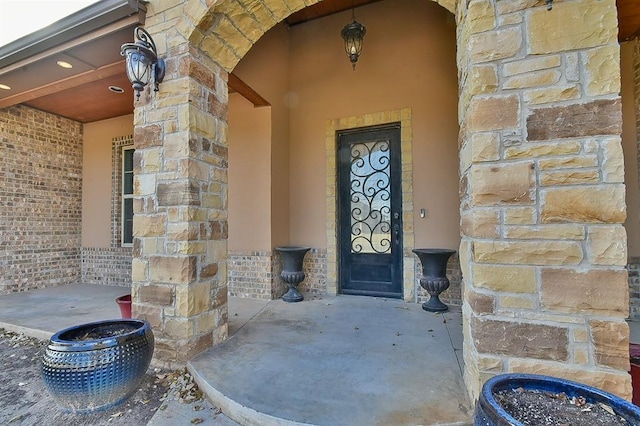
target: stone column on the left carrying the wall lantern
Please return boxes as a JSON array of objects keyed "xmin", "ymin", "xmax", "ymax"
[{"xmin": 132, "ymin": 2, "xmax": 227, "ymax": 367}]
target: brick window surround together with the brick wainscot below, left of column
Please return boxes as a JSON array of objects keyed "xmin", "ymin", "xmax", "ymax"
[{"xmin": 82, "ymin": 135, "xmax": 133, "ymax": 287}]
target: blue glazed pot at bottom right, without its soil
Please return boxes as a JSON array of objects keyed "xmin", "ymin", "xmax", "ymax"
[{"xmin": 473, "ymin": 373, "xmax": 640, "ymax": 426}]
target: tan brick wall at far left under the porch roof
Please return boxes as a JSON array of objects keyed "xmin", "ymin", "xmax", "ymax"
[{"xmin": 0, "ymin": 106, "xmax": 82, "ymax": 293}]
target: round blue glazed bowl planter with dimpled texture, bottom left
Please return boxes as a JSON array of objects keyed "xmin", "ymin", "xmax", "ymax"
[{"xmin": 42, "ymin": 319, "xmax": 154, "ymax": 413}]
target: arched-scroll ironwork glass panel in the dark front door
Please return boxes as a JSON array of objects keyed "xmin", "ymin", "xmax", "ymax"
[{"xmin": 350, "ymin": 140, "xmax": 391, "ymax": 253}]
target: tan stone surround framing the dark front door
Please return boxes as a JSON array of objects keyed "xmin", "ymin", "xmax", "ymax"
[{"xmin": 325, "ymin": 108, "xmax": 418, "ymax": 302}]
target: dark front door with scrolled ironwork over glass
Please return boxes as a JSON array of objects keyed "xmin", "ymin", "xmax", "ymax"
[{"xmin": 337, "ymin": 124, "xmax": 402, "ymax": 298}]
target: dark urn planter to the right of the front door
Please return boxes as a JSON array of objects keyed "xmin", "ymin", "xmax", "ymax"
[{"xmin": 412, "ymin": 249, "xmax": 456, "ymax": 312}]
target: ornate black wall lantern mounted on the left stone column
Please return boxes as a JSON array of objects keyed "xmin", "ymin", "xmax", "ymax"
[{"xmin": 120, "ymin": 27, "xmax": 166, "ymax": 100}]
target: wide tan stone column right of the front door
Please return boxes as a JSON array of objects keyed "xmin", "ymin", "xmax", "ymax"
[{"xmin": 457, "ymin": 0, "xmax": 631, "ymax": 399}]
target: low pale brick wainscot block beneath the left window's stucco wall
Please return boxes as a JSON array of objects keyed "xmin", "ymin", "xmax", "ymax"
[{"xmin": 82, "ymin": 247, "xmax": 131, "ymax": 289}]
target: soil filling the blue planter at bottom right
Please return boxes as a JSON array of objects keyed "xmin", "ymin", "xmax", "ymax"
[{"xmin": 493, "ymin": 388, "xmax": 632, "ymax": 426}]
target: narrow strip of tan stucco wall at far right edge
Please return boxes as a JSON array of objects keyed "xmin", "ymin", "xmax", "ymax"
[{"xmin": 620, "ymin": 43, "xmax": 640, "ymax": 257}]
